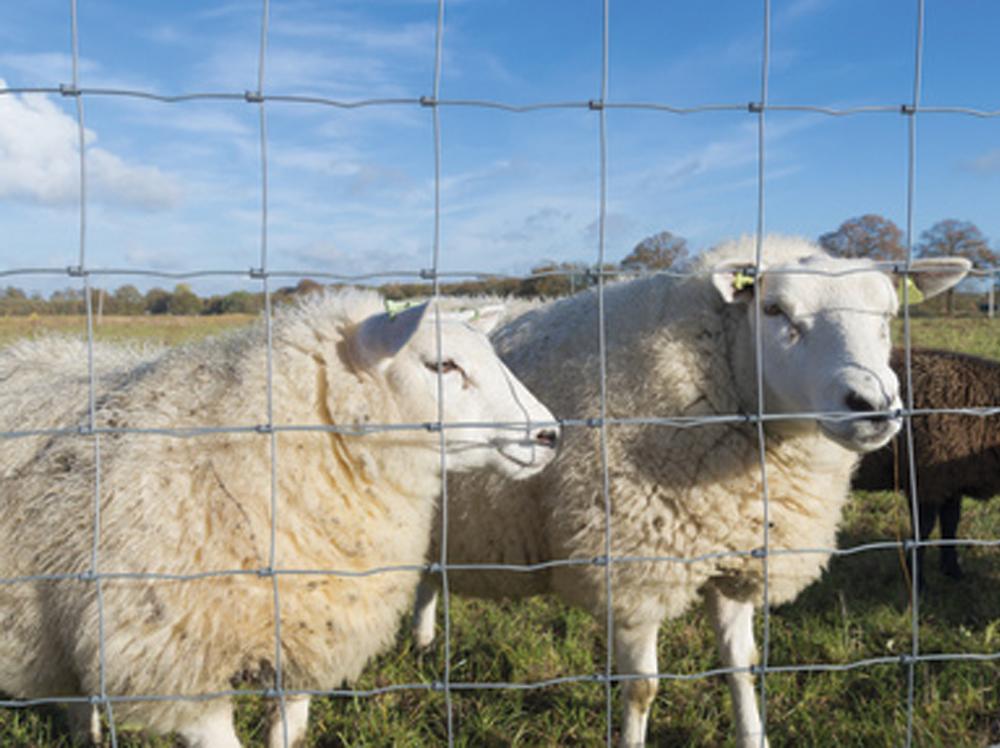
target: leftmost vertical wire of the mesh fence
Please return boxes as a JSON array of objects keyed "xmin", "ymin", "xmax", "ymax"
[{"xmin": 70, "ymin": 0, "xmax": 118, "ymax": 748}]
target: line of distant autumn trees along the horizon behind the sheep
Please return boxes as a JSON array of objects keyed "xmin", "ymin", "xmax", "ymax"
[{"xmin": 0, "ymin": 214, "xmax": 1000, "ymax": 316}]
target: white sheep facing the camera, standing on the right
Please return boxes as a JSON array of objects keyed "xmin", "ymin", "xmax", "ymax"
[{"xmin": 414, "ymin": 237, "xmax": 968, "ymax": 746}]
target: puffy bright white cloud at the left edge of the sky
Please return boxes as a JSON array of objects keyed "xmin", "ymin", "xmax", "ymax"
[{"xmin": 0, "ymin": 81, "xmax": 181, "ymax": 210}]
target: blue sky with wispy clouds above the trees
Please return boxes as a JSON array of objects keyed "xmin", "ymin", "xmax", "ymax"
[{"xmin": 0, "ymin": 0, "xmax": 1000, "ymax": 292}]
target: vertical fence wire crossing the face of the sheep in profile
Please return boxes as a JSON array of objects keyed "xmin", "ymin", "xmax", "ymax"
[{"xmin": 429, "ymin": 0, "xmax": 455, "ymax": 748}]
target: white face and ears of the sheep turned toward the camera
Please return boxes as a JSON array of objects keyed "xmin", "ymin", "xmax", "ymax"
[{"xmin": 714, "ymin": 255, "xmax": 968, "ymax": 452}]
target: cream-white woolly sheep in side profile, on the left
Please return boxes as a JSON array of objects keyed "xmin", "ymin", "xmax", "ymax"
[{"xmin": 0, "ymin": 291, "xmax": 558, "ymax": 748}]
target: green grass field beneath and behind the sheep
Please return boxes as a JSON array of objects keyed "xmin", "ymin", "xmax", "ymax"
[{"xmin": 0, "ymin": 317, "xmax": 1000, "ymax": 748}]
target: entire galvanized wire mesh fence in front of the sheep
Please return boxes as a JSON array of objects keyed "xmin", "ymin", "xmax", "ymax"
[{"xmin": 0, "ymin": 0, "xmax": 1000, "ymax": 746}]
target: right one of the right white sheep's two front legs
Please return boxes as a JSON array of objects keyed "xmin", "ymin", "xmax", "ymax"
[{"xmin": 706, "ymin": 586, "xmax": 768, "ymax": 748}]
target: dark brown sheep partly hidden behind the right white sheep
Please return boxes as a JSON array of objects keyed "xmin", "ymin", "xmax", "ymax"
[{"xmin": 853, "ymin": 348, "xmax": 1000, "ymax": 585}]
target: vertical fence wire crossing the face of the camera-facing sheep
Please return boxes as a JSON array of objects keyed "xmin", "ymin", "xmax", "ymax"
[{"xmin": 751, "ymin": 0, "xmax": 771, "ymax": 748}]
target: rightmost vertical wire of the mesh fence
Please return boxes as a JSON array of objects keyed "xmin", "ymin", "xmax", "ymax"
[{"xmin": 901, "ymin": 0, "xmax": 924, "ymax": 748}]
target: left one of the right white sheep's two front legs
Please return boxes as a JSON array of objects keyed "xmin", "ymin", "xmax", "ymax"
[{"xmin": 615, "ymin": 621, "xmax": 660, "ymax": 748}]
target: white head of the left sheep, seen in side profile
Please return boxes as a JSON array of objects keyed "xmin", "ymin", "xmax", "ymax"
[{"xmin": 354, "ymin": 304, "xmax": 559, "ymax": 478}]
